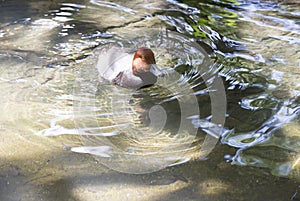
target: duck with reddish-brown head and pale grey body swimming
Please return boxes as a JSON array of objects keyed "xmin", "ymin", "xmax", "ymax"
[{"xmin": 97, "ymin": 47, "xmax": 158, "ymax": 89}]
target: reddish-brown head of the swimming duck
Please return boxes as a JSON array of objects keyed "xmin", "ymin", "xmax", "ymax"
[{"xmin": 132, "ymin": 47, "xmax": 156, "ymax": 75}]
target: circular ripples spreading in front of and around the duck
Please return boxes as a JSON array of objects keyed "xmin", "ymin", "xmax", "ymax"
[{"xmin": 39, "ymin": 32, "xmax": 227, "ymax": 173}]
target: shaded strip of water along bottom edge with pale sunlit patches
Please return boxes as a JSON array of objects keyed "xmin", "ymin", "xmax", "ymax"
[{"xmin": 0, "ymin": 146, "xmax": 300, "ymax": 201}]
